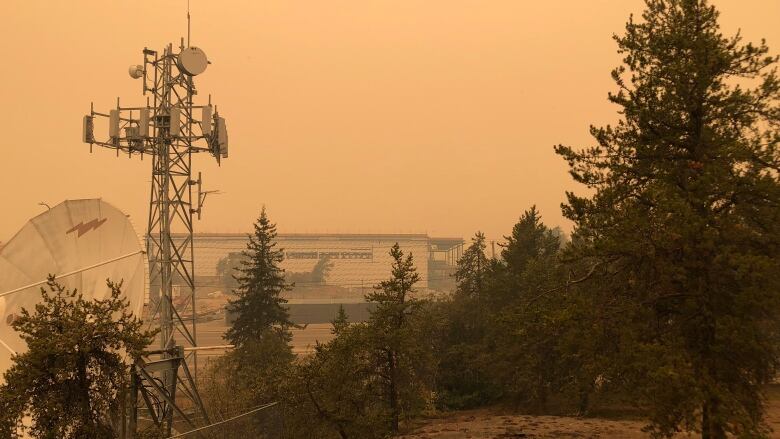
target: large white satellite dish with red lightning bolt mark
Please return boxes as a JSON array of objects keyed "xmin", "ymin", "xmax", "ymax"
[{"xmin": 0, "ymin": 199, "xmax": 148, "ymax": 384}]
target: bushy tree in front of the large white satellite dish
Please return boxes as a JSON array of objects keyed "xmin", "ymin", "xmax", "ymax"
[{"xmin": 0, "ymin": 277, "xmax": 154, "ymax": 438}]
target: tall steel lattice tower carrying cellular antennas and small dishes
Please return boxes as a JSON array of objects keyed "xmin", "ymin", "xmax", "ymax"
[{"xmin": 83, "ymin": 32, "xmax": 228, "ymax": 437}]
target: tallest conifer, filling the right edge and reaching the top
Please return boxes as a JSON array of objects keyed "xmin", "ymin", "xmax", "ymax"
[{"xmin": 556, "ymin": 0, "xmax": 780, "ymax": 439}]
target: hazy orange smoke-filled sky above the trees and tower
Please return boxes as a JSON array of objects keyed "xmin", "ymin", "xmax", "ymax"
[{"xmin": 0, "ymin": 0, "xmax": 780, "ymax": 241}]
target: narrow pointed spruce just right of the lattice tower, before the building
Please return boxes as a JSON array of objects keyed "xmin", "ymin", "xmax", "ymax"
[{"xmin": 226, "ymin": 207, "xmax": 293, "ymax": 348}]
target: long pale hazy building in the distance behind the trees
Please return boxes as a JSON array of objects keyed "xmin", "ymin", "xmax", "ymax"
[{"xmin": 189, "ymin": 233, "xmax": 464, "ymax": 292}]
